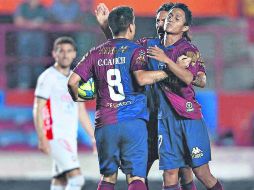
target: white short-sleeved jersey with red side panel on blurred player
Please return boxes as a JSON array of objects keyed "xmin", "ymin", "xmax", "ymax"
[{"xmin": 35, "ymin": 66, "xmax": 78, "ymax": 139}]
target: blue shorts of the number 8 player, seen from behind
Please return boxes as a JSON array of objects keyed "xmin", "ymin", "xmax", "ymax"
[{"xmin": 95, "ymin": 119, "xmax": 148, "ymax": 178}]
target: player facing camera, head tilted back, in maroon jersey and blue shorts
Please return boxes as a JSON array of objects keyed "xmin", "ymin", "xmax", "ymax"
[{"xmin": 148, "ymin": 3, "xmax": 223, "ymax": 190}]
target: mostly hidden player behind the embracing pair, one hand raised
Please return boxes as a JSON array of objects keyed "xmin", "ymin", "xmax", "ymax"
[{"xmin": 95, "ymin": 3, "xmax": 206, "ymax": 190}]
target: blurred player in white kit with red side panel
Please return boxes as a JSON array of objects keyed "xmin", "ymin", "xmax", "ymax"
[{"xmin": 33, "ymin": 37, "xmax": 95, "ymax": 190}]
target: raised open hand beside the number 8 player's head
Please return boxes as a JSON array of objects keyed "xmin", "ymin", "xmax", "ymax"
[{"xmin": 95, "ymin": 3, "xmax": 109, "ymax": 27}]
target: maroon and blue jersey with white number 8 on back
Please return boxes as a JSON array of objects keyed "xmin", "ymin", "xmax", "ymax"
[{"xmin": 74, "ymin": 38, "xmax": 148, "ymax": 127}]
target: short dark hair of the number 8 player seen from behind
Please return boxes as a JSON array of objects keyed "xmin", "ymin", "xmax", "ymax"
[{"xmin": 108, "ymin": 6, "xmax": 134, "ymax": 36}]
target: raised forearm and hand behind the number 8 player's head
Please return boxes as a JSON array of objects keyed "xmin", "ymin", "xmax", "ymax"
[{"xmin": 95, "ymin": 3, "xmax": 112, "ymax": 39}]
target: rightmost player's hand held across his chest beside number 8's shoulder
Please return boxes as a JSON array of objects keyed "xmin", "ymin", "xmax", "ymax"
[{"xmin": 147, "ymin": 46, "xmax": 170, "ymax": 63}]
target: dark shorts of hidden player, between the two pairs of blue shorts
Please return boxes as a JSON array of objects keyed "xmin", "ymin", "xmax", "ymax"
[{"xmin": 147, "ymin": 112, "xmax": 159, "ymax": 163}]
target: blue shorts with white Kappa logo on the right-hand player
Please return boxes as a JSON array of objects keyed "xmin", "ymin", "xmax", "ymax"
[{"xmin": 158, "ymin": 106, "xmax": 211, "ymax": 170}]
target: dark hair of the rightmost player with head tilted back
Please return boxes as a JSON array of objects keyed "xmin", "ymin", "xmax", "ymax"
[{"xmin": 172, "ymin": 3, "xmax": 192, "ymax": 41}]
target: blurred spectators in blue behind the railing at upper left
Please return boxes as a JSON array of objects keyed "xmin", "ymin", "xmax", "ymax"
[{"xmin": 9, "ymin": 0, "xmax": 97, "ymax": 89}]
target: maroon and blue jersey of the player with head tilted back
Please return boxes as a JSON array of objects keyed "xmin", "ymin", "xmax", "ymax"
[{"xmin": 160, "ymin": 38, "xmax": 205, "ymax": 119}]
